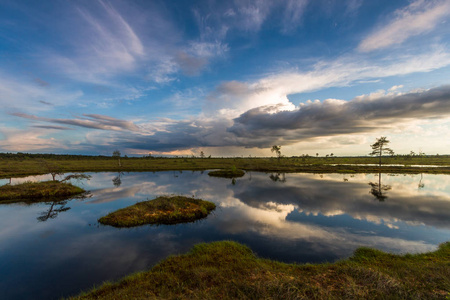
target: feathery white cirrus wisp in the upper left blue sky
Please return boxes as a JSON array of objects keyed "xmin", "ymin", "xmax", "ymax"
[{"xmin": 45, "ymin": 1, "xmax": 145, "ymax": 83}]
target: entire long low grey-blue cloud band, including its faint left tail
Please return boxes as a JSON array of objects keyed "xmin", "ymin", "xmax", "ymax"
[{"xmin": 70, "ymin": 86, "xmax": 450, "ymax": 152}]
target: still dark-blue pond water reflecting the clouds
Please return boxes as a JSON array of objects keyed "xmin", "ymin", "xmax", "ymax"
[{"xmin": 0, "ymin": 171, "xmax": 450, "ymax": 299}]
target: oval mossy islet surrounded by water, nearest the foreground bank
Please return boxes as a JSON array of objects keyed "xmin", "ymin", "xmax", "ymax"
[{"xmin": 98, "ymin": 196, "xmax": 216, "ymax": 227}]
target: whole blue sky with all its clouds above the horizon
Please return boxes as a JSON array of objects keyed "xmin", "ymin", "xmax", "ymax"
[{"xmin": 0, "ymin": 0, "xmax": 450, "ymax": 157}]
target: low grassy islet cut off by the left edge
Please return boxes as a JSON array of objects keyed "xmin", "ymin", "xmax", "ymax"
[{"xmin": 0, "ymin": 181, "xmax": 85, "ymax": 202}]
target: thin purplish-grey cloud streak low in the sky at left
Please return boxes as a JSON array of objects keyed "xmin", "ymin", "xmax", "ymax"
[{"xmin": 12, "ymin": 113, "xmax": 139, "ymax": 131}]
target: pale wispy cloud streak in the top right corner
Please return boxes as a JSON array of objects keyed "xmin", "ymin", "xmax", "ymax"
[{"xmin": 358, "ymin": 0, "xmax": 450, "ymax": 52}]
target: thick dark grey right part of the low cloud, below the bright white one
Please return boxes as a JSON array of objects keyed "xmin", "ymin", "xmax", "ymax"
[{"xmin": 228, "ymin": 85, "xmax": 450, "ymax": 147}]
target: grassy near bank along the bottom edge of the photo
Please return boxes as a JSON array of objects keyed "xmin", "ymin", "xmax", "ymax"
[{"xmin": 72, "ymin": 242, "xmax": 450, "ymax": 299}]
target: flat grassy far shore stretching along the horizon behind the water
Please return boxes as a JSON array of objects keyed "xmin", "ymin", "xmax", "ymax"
[{"xmin": 0, "ymin": 155, "xmax": 450, "ymax": 178}]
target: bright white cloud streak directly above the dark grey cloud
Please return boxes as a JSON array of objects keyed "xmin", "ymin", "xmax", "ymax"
[{"xmin": 204, "ymin": 47, "xmax": 450, "ymax": 118}]
